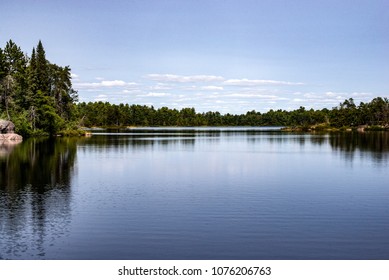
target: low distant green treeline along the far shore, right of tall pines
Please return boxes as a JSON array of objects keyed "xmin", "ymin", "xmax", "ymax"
[{"xmin": 77, "ymin": 97, "xmax": 389, "ymax": 128}]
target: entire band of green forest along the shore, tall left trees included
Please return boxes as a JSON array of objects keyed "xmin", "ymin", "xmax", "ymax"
[{"xmin": 0, "ymin": 40, "xmax": 389, "ymax": 137}]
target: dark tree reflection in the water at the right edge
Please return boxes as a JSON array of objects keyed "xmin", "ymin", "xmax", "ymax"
[{"xmin": 329, "ymin": 131, "xmax": 389, "ymax": 162}]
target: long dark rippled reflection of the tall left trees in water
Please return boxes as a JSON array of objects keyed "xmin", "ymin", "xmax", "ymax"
[{"xmin": 0, "ymin": 139, "xmax": 76, "ymax": 259}]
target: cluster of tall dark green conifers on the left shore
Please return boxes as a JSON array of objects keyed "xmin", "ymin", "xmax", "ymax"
[{"xmin": 0, "ymin": 40, "xmax": 78, "ymax": 136}]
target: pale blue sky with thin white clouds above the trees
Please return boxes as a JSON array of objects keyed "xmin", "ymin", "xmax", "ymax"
[{"xmin": 0, "ymin": 0, "xmax": 389, "ymax": 113}]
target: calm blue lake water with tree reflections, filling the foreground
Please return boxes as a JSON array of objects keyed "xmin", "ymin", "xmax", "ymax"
[{"xmin": 0, "ymin": 128, "xmax": 389, "ymax": 260}]
